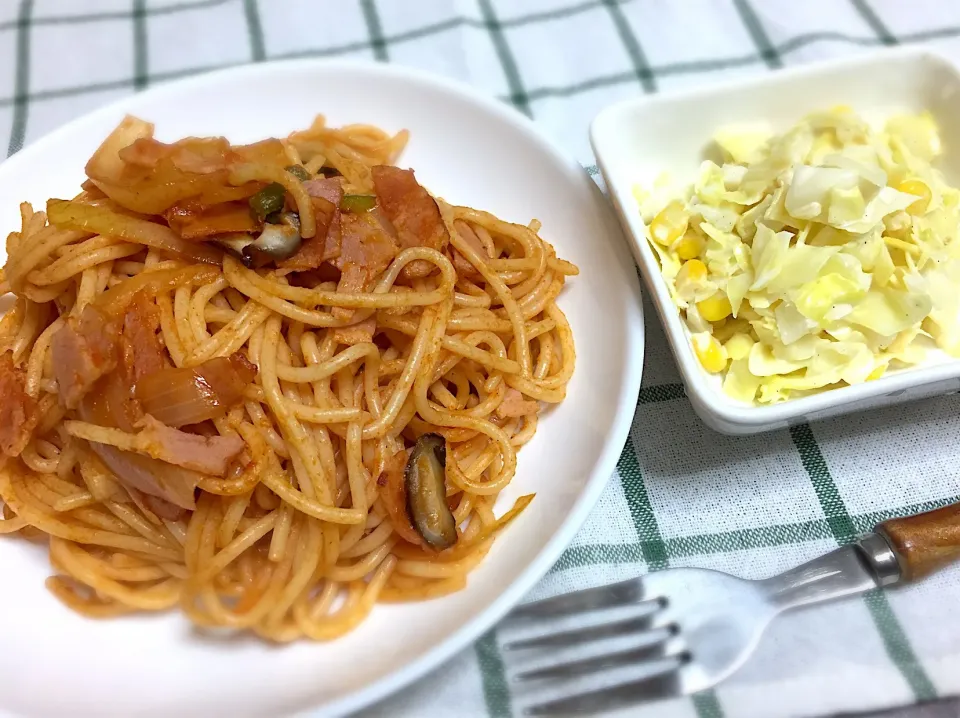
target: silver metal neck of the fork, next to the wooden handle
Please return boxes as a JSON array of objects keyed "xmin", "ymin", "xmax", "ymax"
[{"xmin": 758, "ymin": 534, "xmax": 900, "ymax": 610}]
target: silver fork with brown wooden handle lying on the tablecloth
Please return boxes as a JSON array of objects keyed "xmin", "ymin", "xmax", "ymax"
[{"xmin": 501, "ymin": 503, "xmax": 960, "ymax": 715}]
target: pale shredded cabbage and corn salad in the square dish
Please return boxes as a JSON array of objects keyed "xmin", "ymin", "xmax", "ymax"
[{"xmin": 635, "ymin": 107, "xmax": 960, "ymax": 403}]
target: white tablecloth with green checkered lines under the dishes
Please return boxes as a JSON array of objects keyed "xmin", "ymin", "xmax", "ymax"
[{"xmin": 0, "ymin": 0, "xmax": 960, "ymax": 718}]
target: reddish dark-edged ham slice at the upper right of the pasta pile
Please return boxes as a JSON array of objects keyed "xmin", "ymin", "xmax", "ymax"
[{"xmin": 372, "ymin": 165, "xmax": 450, "ymax": 279}]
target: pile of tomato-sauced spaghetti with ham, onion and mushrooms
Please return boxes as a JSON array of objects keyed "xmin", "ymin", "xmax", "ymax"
[{"xmin": 0, "ymin": 117, "xmax": 577, "ymax": 641}]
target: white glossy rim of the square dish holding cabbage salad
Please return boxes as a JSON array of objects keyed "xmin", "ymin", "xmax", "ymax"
[{"xmin": 590, "ymin": 45, "xmax": 960, "ymax": 431}]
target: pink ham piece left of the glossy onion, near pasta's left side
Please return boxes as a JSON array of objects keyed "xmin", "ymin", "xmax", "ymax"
[{"xmin": 50, "ymin": 304, "xmax": 120, "ymax": 409}]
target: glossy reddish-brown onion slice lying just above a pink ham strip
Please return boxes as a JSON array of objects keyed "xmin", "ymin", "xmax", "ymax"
[{"xmin": 136, "ymin": 354, "xmax": 256, "ymax": 426}]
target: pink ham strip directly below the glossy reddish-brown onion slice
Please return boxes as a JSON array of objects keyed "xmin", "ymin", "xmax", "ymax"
[{"xmin": 138, "ymin": 414, "xmax": 244, "ymax": 476}]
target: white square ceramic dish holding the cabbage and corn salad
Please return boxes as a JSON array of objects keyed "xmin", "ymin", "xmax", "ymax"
[{"xmin": 590, "ymin": 48, "xmax": 960, "ymax": 434}]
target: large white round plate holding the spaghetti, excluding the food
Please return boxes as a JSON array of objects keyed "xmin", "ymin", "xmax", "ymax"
[{"xmin": 0, "ymin": 61, "xmax": 643, "ymax": 717}]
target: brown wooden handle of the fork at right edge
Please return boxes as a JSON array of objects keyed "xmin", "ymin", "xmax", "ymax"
[{"xmin": 876, "ymin": 503, "xmax": 960, "ymax": 582}]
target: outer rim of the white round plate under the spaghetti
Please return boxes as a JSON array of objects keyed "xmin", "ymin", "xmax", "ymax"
[{"xmin": 0, "ymin": 58, "xmax": 646, "ymax": 716}]
